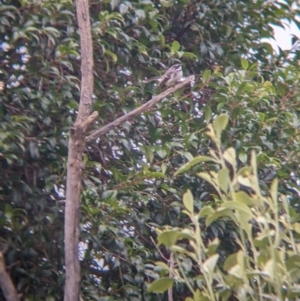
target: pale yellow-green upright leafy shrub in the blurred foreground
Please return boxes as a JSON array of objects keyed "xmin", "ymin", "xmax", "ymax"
[{"xmin": 148, "ymin": 115, "xmax": 300, "ymax": 301}]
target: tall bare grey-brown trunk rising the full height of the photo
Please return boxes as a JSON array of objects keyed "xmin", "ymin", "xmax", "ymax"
[{"xmin": 64, "ymin": 0, "xmax": 93, "ymax": 301}]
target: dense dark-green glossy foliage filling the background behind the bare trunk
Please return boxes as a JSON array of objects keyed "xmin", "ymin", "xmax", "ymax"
[{"xmin": 0, "ymin": 0, "xmax": 300, "ymax": 300}]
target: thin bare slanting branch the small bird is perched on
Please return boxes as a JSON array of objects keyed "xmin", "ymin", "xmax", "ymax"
[{"xmin": 85, "ymin": 75, "xmax": 194, "ymax": 142}]
